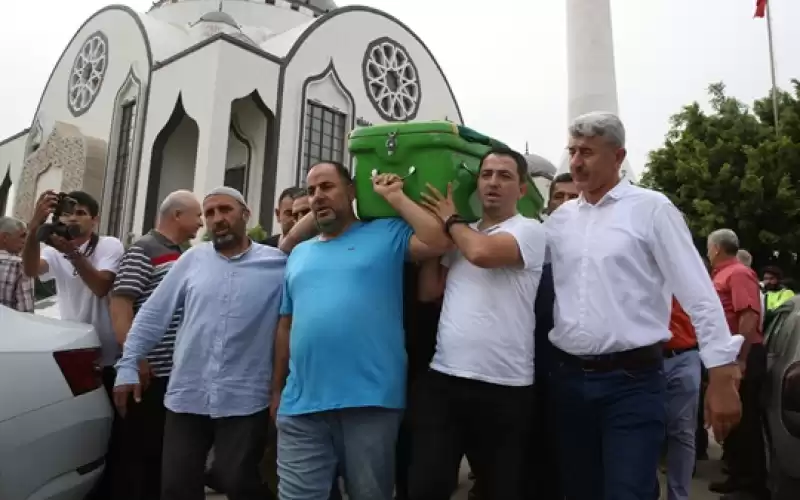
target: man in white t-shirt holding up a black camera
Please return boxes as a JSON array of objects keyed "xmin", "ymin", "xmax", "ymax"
[{"xmin": 22, "ymin": 191, "xmax": 124, "ymax": 499}]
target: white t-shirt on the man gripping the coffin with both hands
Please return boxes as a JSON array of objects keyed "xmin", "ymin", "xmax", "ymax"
[{"xmin": 431, "ymin": 214, "xmax": 545, "ymax": 386}]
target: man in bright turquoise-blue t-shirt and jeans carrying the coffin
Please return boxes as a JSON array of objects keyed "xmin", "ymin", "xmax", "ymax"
[{"xmin": 271, "ymin": 162, "xmax": 449, "ymax": 500}]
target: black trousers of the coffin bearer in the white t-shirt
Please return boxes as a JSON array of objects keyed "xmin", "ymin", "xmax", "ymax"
[{"xmin": 408, "ymin": 370, "xmax": 534, "ymax": 500}]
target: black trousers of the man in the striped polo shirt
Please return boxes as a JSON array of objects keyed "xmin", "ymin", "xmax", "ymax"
[{"xmin": 115, "ymin": 377, "xmax": 169, "ymax": 500}]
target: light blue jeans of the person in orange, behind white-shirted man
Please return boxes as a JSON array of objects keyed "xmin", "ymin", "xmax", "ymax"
[{"xmin": 664, "ymin": 350, "xmax": 702, "ymax": 500}]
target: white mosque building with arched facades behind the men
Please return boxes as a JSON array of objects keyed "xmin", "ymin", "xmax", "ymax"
[{"xmin": 0, "ymin": 0, "xmax": 463, "ymax": 242}]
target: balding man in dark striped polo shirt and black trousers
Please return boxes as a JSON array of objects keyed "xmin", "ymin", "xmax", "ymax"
[{"xmin": 110, "ymin": 191, "xmax": 203, "ymax": 500}]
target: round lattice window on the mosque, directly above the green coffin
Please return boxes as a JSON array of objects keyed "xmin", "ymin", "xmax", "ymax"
[{"xmin": 363, "ymin": 38, "xmax": 422, "ymax": 122}]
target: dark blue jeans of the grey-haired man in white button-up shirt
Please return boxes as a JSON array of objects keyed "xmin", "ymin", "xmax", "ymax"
[{"xmin": 550, "ymin": 361, "xmax": 666, "ymax": 500}]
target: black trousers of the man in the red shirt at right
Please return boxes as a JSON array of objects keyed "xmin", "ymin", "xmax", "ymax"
[{"xmin": 725, "ymin": 344, "xmax": 767, "ymax": 496}]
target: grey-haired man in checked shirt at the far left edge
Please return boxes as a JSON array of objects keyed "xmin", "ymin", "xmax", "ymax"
[{"xmin": 0, "ymin": 217, "xmax": 33, "ymax": 312}]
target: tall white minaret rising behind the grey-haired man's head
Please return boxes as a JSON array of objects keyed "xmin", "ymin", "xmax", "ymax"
[{"xmin": 558, "ymin": 0, "xmax": 635, "ymax": 179}]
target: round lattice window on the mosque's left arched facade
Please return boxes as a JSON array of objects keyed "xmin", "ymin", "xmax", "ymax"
[{"xmin": 67, "ymin": 31, "xmax": 108, "ymax": 116}]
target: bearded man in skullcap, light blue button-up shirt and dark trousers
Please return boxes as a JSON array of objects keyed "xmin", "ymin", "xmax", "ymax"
[{"xmin": 114, "ymin": 187, "xmax": 286, "ymax": 500}]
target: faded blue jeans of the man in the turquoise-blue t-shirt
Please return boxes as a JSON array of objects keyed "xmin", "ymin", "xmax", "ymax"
[{"xmin": 276, "ymin": 408, "xmax": 403, "ymax": 500}]
